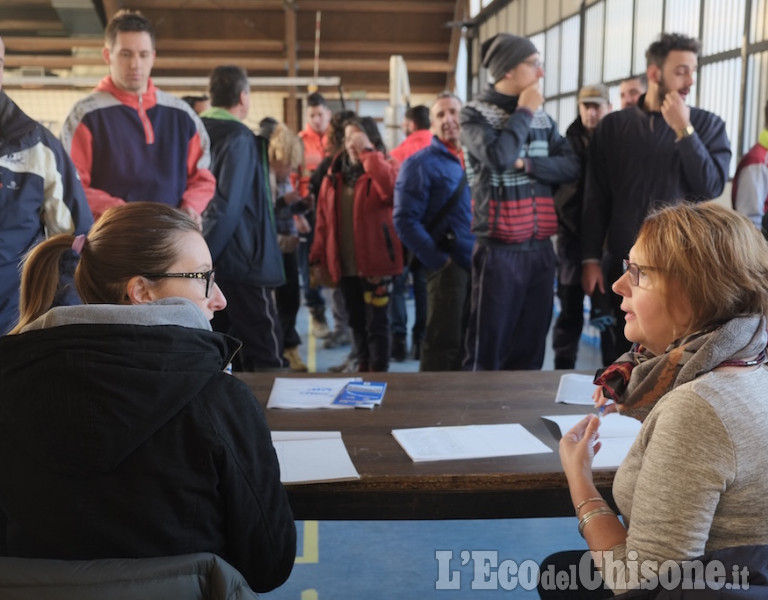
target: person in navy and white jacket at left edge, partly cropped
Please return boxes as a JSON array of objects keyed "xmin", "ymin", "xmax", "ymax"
[{"xmin": 0, "ymin": 38, "xmax": 93, "ymax": 335}]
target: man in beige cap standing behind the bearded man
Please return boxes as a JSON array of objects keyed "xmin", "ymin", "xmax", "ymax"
[{"xmin": 552, "ymin": 83, "xmax": 614, "ymax": 369}]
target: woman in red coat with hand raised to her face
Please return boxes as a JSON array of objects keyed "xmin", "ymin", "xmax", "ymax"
[{"xmin": 310, "ymin": 119, "xmax": 403, "ymax": 371}]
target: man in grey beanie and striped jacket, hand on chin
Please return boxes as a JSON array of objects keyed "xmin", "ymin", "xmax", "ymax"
[{"xmin": 461, "ymin": 33, "xmax": 579, "ymax": 370}]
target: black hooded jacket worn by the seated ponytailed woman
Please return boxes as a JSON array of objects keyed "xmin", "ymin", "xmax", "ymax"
[{"xmin": 0, "ymin": 305, "xmax": 296, "ymax": 591}]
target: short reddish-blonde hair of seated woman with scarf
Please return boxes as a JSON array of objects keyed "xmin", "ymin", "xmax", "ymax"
[{"xmin": 635, "ymin": 202, "xmax": 768, "ymax": 333}]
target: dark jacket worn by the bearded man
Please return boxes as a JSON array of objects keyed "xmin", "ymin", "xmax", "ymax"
[{"xmin": 581, "ymin": 96, "xmax": 731, "ymax": 263}]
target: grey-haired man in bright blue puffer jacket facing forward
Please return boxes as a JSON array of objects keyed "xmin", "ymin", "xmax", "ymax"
[{"xmin": 394, "ymin": 92, "xmax": 474, "ymax": 371}]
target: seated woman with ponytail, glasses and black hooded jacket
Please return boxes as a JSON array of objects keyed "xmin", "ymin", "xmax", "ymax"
[{"xmin": 0, "ymin": 202, "xmax": 296, "ymax": 591}]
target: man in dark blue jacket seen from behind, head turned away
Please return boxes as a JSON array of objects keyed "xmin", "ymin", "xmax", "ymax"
[{"xmin": 200, "ymin": 65, "xmax": 287, "ymax": 371}]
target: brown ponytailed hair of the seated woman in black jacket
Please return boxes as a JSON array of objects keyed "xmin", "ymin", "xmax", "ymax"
[{"xmin": 11, "ymin": 202, "xmax": 200, "ymax": 333}]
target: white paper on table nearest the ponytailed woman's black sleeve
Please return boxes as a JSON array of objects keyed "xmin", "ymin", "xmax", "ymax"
[{"xmin": 272, "ymin": 431, "xmax": 360, "ymax": 483}]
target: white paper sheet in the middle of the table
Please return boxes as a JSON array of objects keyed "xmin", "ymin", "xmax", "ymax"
[{"xmin": 392, "ymin": 423, "xmax": 552, "ymax": 462}]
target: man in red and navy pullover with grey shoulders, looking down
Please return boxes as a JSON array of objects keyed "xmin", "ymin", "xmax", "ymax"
[{"xmin": 61, "ymin": 10, "xmax": 216, "ymax": 223}]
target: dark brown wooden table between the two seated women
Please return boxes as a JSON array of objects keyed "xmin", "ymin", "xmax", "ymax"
[{"xmin": 238, "ymin": 371, "xmax": 614, "ymax": 520}]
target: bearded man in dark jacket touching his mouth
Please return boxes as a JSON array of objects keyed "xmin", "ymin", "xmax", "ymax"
[{"xmin": 581, "ymin": 33, "xmax": 731, "ymax": 356}]
